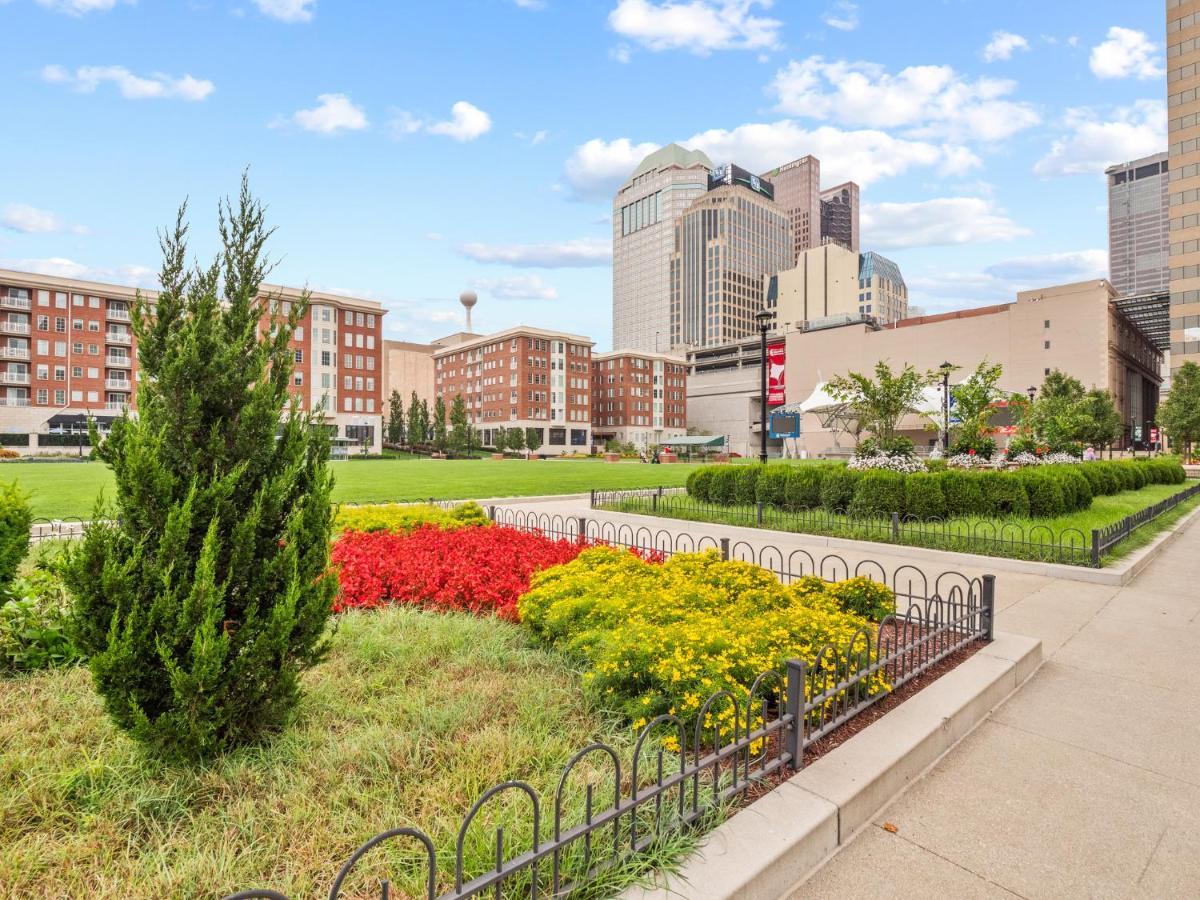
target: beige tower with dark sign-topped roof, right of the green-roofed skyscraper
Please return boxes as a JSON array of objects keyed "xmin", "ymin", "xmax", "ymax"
[{"xmin": 671, "ymin": 166, "xmax": 794, "ymax": 348}]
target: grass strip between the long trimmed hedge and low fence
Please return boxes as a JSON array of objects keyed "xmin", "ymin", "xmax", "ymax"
[{"xmin": 605, "ymin": 481, "xmax": 1200, "ymax": 564}]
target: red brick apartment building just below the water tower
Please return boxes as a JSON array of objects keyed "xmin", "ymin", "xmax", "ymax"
[{"xmin": 433, "ymin": 325, "xmax": 593, "ymax": 455}]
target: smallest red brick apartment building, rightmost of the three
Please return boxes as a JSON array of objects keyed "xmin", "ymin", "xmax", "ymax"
[{"xmin": 592, "ymin": 350, "xmax": 688, "ymax": 449}]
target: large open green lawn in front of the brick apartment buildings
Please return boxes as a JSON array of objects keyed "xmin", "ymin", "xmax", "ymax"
[{"xmin": 0, "ymin": 458, "xmax": 695, "ymax": 518}]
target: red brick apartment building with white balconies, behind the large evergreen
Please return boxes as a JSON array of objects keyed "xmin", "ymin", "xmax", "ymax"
[{"xmin": 0, "ymin": 269, "xmax": 385, "ymax": 450}]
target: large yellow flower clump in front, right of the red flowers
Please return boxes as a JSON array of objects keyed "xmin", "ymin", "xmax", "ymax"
[{"xmin": 518, "ymin": 547, "xmax": 890, "ymax": 736}]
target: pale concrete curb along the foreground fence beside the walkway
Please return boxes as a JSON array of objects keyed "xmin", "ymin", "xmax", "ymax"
[{"xmin": 620, "ymin": 634, "xmax": 1042, "ymax": 900}]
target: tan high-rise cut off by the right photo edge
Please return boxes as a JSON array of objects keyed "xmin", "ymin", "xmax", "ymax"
[{"xmin": 1166, "ymin": 0, "xmax": 1200, "ymax": 372}]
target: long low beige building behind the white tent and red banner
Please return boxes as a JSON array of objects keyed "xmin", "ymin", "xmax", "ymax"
[{"xmin": 786, "ymin": 280, "xmax": 1163, "ymax": 456}]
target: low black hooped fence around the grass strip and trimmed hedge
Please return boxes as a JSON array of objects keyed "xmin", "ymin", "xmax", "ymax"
[{"xmin": 590, "ymin": 485, "xmax": 1200, "ymax": 569}]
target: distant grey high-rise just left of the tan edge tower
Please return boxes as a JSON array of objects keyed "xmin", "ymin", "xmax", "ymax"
[{"xmin": 1104, "ymin": 152, "xmax": 1170, "ymax": 296}]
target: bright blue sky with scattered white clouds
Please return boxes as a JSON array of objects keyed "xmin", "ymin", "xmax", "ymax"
[{"xmin": 0, "ymin": 0, "xmax": 1166, "ymax": 348}]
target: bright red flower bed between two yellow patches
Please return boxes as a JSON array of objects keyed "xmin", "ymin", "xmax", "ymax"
[{"xmin": 332, "ymin": 526, "xmax": 584, "ymax": 620}]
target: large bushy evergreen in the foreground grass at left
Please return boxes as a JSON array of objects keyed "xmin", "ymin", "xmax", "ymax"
[{"xmin": 65, "ymin": 178, "xmax": 336, "ymax": 760}]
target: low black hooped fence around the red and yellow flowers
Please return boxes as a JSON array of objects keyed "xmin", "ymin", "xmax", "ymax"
[{"xmin": 226, "ymin": 508, "xmax": 995, "ymax": 900}]
